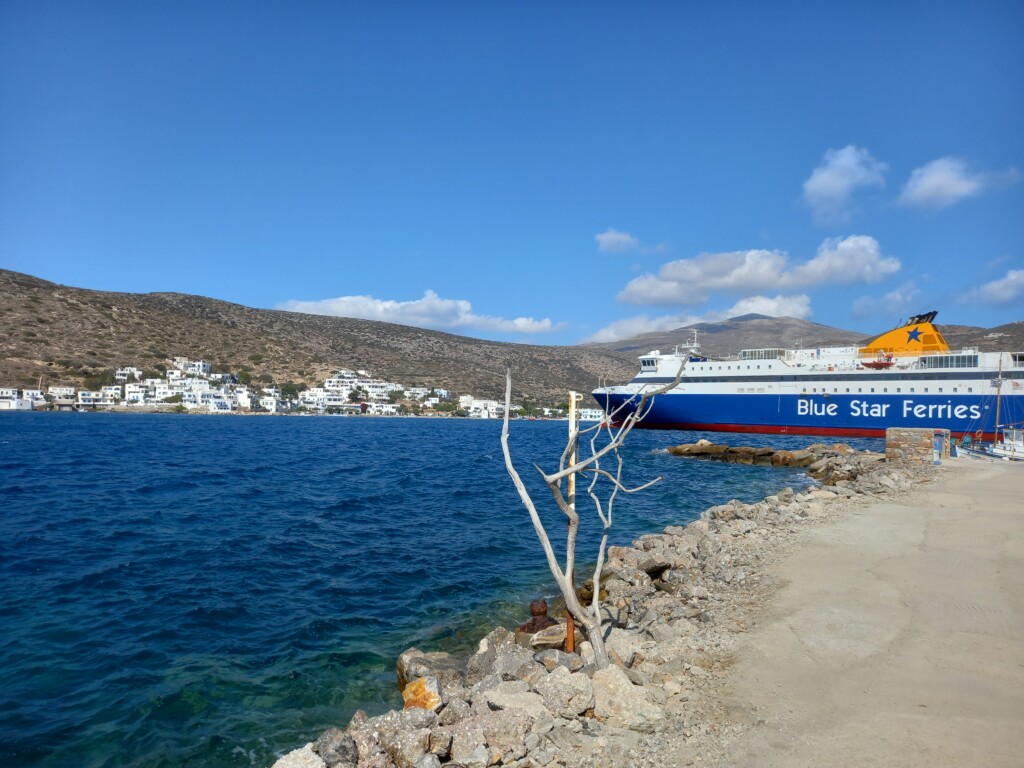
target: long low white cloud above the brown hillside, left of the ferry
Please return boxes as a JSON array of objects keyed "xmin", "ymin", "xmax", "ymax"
[{"xmin": 278, "ymin": 291, "xmax": 562, "ymax": 334}]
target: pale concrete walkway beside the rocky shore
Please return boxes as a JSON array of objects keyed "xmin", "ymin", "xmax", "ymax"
[{"xmin": 722, "ymin": 459, "xmax": 1024, "ymax": 768}]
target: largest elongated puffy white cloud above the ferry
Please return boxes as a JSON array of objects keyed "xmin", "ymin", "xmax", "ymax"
[{"xmin": 618, "ymin": 234, "xmax": 900, "ymax": 306}]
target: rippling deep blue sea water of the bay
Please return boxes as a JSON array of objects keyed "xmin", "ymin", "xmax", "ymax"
[{"xmin": 0, "ymin": 414, "xmax": 881, "ymax": 768}]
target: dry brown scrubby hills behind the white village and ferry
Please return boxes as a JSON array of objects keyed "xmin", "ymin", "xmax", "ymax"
[{"xmin": 0, "ymin": 269, "xmax": 1024, "ymax": 403}]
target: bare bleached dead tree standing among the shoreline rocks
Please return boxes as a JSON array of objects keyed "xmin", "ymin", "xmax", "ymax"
[{"xmin": 502, "ymin": 367, "xmax": 683, "ymax": 668}]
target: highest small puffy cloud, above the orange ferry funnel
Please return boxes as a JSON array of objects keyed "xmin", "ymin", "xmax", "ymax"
[{"xmin": 804, "ymin": 144, "xmax": 889, "ymax": 223}]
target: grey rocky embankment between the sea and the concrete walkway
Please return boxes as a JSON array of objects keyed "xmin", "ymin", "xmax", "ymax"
[{"xmin": 274, "ymin": 450, "xmax": 934, "ymax": 768}]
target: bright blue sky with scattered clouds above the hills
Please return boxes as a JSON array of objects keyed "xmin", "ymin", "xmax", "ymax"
[{"xmin": 0, "ymin": 0, "xmax": 1024, "ymax": 344}]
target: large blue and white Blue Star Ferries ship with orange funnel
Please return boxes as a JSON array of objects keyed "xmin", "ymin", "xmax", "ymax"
[{"xmin": 593, "ymin": 312, "xmax": 1024, "ymax": 439}]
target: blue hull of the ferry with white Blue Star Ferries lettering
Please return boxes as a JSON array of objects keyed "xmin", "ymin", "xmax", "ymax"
[{"xmin": 594, "ymin": 390, "xmax": 1024, "ymax": 439}]
